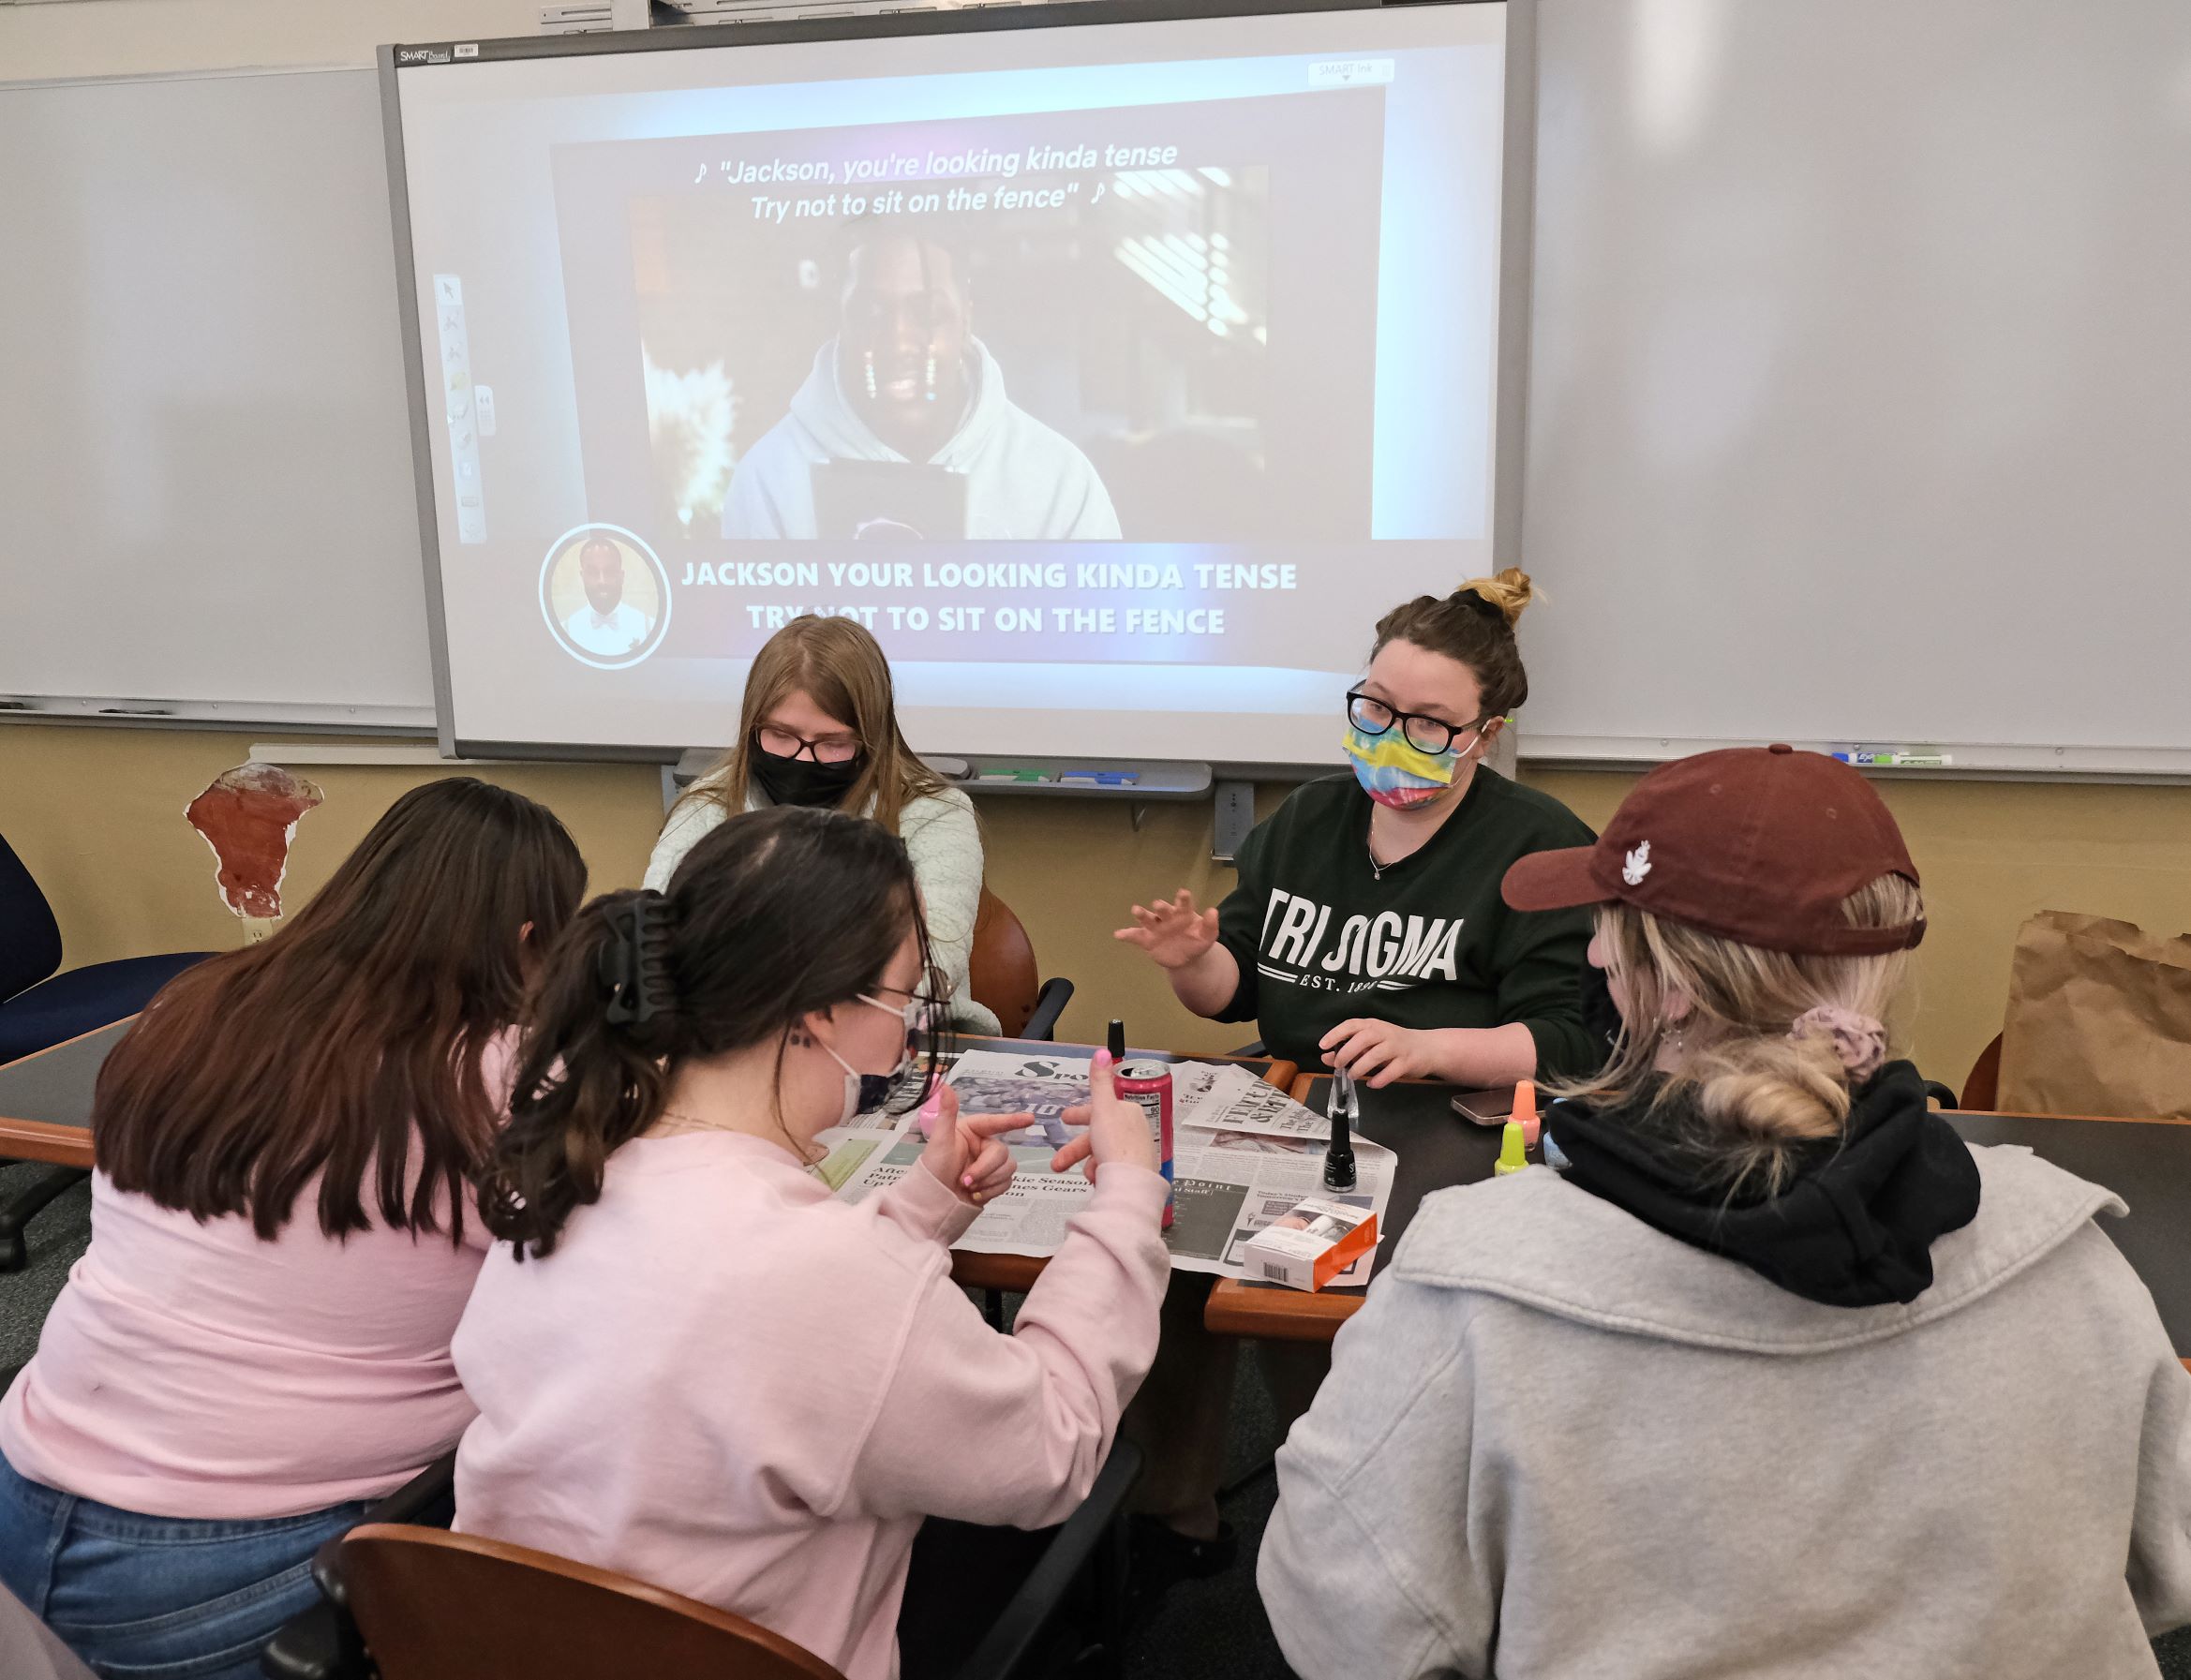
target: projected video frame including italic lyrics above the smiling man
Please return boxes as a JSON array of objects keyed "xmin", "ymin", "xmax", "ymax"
[{"xmin": 557, "ymin": 90, "xmax": 1382, "ymax": 543}]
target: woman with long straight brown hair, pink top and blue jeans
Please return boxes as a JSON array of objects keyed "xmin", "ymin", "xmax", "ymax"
[{"xmin": 0, "ymin": 778, "xmax": 585, "ymax": 1680}]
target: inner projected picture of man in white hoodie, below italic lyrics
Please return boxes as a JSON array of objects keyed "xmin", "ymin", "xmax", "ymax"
[{"xmin": 631, "ymin": 147, "xmax": 1277, "ymax": 541}]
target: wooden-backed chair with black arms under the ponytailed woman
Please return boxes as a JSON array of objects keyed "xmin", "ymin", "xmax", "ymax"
[{"xmin": 259, "ymin": 1441, "xmax": 1141, "ymax": 1680}]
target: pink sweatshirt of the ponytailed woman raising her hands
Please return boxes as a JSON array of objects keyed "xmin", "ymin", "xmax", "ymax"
[{"xmin": 442, "ymin": 1133, "xmax": 1170, "ymax": 1680}]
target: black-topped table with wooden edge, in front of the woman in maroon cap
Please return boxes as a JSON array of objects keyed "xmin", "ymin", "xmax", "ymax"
[{"xmin": 1203, "ymin": 1073, "xmax": 2191, "ymax": 1367}]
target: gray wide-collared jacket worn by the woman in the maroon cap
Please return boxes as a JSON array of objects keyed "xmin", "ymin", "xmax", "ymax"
[{"xmin": 1258, "ymin": 1148, "xmax": 2191, "ymax": 1680}]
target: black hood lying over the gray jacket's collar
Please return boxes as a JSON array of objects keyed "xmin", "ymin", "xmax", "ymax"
[{"xmin": 1544, "ymin": 1063, "xmax": 1978, "ymax": 1308}]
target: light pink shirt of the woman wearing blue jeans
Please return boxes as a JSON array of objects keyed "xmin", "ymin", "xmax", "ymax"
[{"xmin": 0, "ymin": 1172, "xmax": 488, "ymax": 1518}]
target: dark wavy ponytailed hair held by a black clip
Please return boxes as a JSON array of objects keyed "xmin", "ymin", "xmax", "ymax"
[{"xmin": 480, "ymin": 806, "xmax": 933, "ymax": 1259}]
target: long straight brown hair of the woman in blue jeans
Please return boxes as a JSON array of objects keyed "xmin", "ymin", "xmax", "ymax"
[{"xmin": 92, "ymin": 776, "xmax": 585, "ymax": 1241}]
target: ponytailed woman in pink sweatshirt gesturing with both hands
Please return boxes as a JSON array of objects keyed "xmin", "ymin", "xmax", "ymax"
[{"xmin": 455, "ymin": 806, "xmax": 1168, "ymax": 1680}]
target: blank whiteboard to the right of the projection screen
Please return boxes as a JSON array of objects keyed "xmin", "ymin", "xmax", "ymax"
[{"xmin": 1521, "ymin": 0, "xmax": 2191, "ymax": 773}]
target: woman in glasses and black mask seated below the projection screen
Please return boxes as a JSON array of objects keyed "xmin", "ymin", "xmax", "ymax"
[{"xmin": 647, "ymin": 616, "xmax": 999, "ymax": 1033}]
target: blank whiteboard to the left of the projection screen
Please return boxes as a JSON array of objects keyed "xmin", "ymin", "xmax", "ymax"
[{"xmin": 0, "ymin": 70, "xmax": 434, "ymax": 729}]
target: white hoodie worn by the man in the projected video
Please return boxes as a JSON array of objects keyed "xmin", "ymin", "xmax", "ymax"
[{"xmin": 723, "ymin": 339, "xmax": 1117, "ymax": 541}]
